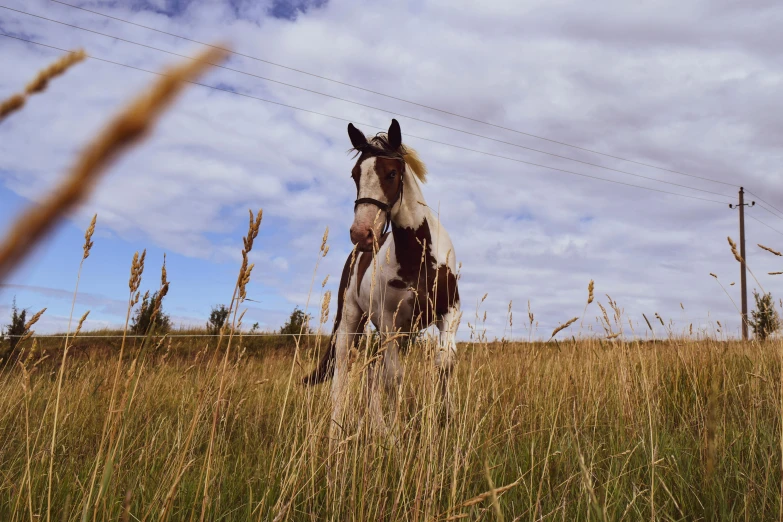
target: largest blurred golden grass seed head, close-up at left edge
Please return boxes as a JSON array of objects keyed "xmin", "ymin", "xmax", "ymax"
[{"xmin": 0, "ymin": 45, "xmax": 225, "ymax": 281}]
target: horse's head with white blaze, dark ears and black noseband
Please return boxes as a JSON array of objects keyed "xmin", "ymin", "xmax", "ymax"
[{"xmin": 348, "ymin": 120, "xmax": 405, "ymax": 251}]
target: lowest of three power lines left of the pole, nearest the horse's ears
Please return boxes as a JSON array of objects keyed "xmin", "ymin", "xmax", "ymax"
[{"xmin": 0, "ymin": 33, "xmax": 726, "ymax": 205}]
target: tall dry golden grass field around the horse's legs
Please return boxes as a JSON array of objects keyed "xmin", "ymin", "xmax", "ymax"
[{"xmin": 0, "ymin": 332, "xmax": 783, "ymax": 521}]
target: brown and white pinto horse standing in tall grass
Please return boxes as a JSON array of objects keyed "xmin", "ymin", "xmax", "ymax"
[{"xmin": 303, "ymin": 119, "xmax": 461, "ymax": 434}]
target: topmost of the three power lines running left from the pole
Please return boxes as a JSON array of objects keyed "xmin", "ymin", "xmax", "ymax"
[{"xmin": 51, "ymin": 0, "xmax": 735, "ymax": 187}]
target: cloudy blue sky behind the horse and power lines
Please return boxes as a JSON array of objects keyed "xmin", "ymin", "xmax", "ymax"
[{"xmin": 0, "ymin": 0, "xmax": 783, "ymax": 339}]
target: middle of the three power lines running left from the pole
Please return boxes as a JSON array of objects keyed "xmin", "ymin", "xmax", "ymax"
[{"xmin": 0, "ymin": 5, "xmax": 731, "ymax": 198}]
